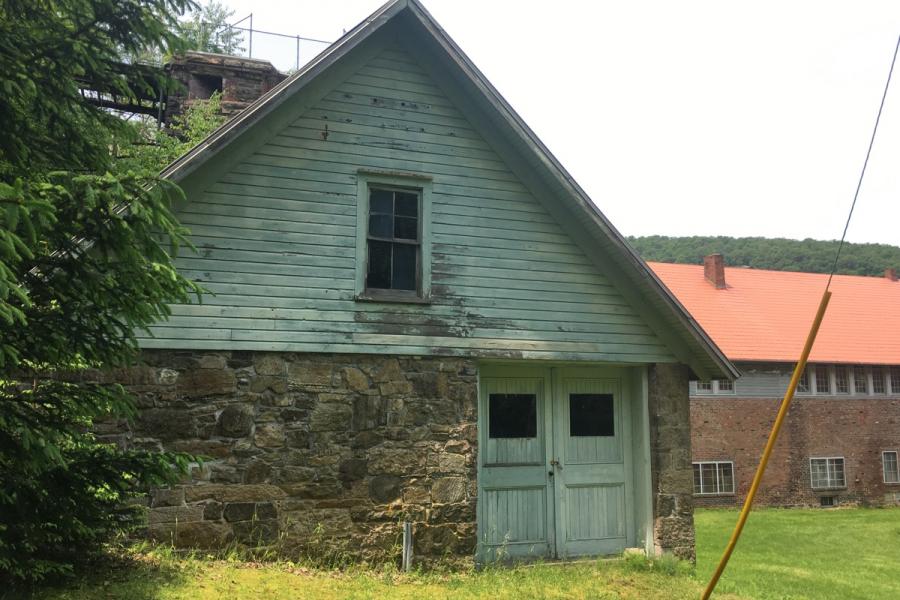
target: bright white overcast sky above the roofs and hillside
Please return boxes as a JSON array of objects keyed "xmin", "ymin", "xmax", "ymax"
[{"xmin": 221, "ymin": 0, "xmax": 900, "ymax": 245}]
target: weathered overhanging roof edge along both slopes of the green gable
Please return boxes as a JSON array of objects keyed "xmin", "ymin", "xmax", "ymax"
[{"xmin": 162, "ymin": 0, "xmax": 739, "ymax": 378}]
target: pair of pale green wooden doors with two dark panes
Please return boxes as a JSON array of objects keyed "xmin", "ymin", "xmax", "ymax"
[{"xmin": 478, "ymin": 366, "xmax": 634, "ymax": 561}]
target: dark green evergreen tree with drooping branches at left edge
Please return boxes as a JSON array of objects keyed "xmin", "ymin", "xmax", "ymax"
[{"xmin": 0, "ymin": 0, "xmax": 198, "ymax": 582}]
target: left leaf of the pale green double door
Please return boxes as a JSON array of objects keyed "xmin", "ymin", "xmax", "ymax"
[{"xmin": 477, "ymin": 368, "xmax": 554, "ymax": 561}]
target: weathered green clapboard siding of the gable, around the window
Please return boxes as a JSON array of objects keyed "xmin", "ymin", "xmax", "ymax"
[{"xmin": 141, "ymin": 46, "xmax": 674, "ymax": 363}]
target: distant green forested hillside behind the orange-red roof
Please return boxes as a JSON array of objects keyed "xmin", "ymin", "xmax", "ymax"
[{"xmin": 628, "ymin": 235, "xmax": 900, "ymax": 276}]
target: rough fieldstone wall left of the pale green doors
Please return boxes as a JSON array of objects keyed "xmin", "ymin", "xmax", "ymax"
[{"xmin": 110, "ymin": 352, "xmax": 477, "ymax": 559}]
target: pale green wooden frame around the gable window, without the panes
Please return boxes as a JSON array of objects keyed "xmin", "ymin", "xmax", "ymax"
[{"xmin": 355, "ymin": 169, "xmax": 432, "ymax": 304}]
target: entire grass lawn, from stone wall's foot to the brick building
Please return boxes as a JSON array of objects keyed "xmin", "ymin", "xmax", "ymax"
[{"xmin": 31, "ymin": 509, "xmax": 900, "ymax": 600}]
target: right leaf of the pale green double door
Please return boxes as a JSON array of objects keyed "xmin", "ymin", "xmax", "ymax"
[{"xmin": 551, "ymin": 368, "xmax": 634, "ymax": 558}]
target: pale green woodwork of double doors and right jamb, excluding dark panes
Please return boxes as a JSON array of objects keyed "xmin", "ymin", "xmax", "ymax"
[{"xmin": 478, "ymin": 365, "xmax": 652, "ymax": 561}]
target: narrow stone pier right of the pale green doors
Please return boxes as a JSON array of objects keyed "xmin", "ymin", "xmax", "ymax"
[{"xmin": 648, "ymin": 364, "xmax": 695, "ymax": 560}]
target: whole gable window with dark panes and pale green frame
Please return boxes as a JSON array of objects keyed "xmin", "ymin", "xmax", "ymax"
[{"xmin": 357, "ymin": 173, "xmax": 431, "ymax": 302}]
